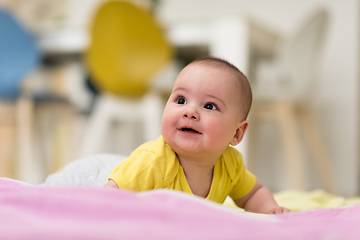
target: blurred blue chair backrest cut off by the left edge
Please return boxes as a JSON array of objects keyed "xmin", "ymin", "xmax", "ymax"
[{"xmin": 0, "ymin": 9, "xmax": 40, "ymax": 98}]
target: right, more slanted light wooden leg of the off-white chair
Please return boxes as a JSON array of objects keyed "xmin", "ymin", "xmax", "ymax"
[{"xmin": 300, "ymin": 107, "xmax": 339, "ymax": 194}]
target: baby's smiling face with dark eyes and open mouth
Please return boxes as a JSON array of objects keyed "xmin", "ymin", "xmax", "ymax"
[{"xmin": 161, "ymin": 63, "xmax": 245, "ymax": 158}]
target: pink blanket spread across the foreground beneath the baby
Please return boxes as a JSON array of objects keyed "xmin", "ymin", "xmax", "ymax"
[{"xmin": 0, "ymin": 178, "xmax": 360, "ymax": 240}]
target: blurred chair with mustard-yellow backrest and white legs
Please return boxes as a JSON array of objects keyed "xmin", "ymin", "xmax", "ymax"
[{"xmin": 79, "ymin": 1, "xmax": 172, "ymax": 157}]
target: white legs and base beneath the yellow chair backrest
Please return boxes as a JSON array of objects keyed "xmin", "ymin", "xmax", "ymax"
[{"xmin": 78, "ymin": 93, "xmax": 164, "ymax": 157}]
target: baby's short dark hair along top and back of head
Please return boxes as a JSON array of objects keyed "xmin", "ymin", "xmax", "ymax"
[{"xmin": 189, "ymin": 56, "xmax": 252, "ymax": 120}]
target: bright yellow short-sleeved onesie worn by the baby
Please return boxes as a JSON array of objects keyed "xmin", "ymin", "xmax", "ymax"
[{"xmin": 109, "ymin": 136, "xmax": 256, "ymax": 203}]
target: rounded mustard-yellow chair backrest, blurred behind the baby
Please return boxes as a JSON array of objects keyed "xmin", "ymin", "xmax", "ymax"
[{"xmin": 85, "ymin": 1, "xmax": 172, "ymax": 96}]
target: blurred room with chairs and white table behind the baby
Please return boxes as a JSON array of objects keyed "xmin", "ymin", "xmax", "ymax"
[{"xmin": 0, "ymin": 0, "xmax": 360, "ymax": 197}]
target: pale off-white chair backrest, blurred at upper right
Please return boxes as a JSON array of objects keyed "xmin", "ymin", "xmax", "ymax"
[{"xmin": 283, "ymin": 9, "xmax": 329, "ymax": 98}]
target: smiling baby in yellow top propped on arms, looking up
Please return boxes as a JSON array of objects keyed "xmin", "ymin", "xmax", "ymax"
[{"xmin": 105, "ymin": 57, "xmax": 289, "ymax": 214}]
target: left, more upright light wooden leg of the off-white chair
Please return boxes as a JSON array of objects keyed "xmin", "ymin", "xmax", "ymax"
[{"xmin": 276, "ymin": 102, "xmax": 306, "ymax": 190}]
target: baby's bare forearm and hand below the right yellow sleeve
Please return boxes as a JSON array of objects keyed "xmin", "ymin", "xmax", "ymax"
[{"xmin": 234, "ymin": 181, "xmax": 290, "ymax": 214}]
